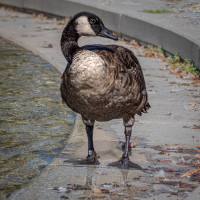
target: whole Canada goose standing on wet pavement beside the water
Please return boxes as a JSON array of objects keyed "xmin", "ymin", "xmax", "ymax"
[{"xmin": 60, "ymin": 12, "xmax": 150, "ymax": 168}]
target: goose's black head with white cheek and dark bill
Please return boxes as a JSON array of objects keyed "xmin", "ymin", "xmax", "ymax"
[{"xmin": 72, "ymin": 12, "xmax": 118, "ymax": 40}]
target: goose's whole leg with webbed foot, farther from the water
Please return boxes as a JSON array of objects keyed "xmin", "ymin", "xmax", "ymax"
[{"xmin": 109, "ymin": 118, "xmax": 141, "ymax": 169}]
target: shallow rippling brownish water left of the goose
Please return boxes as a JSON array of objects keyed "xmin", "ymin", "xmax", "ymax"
[{"xmin": 0, "ymin": 38, "xmax": 75, "ymax": 199}]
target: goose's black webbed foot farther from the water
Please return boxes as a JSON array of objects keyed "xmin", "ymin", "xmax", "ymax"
[{"xmin": 108, "ymin": 156, "xmax": 142, "ymax": 170}]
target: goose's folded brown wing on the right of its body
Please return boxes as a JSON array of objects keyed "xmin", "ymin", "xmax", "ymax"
[{"xmin": 82, "ymin": 44, "xmax": 150, "ymax": 115}]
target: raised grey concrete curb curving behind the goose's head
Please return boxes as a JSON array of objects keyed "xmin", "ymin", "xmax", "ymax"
[{"xmin": 0, "ymin": 0, "xmax": 200, "ymax": 69}]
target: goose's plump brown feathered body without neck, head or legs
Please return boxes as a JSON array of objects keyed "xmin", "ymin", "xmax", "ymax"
[{"xmin": 61, "ymin": 45, "xmax": 150, "ymax": 121}]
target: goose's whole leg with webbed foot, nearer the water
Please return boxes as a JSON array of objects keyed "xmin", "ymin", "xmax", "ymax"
[{"xmin": 75, "ymin": 119, "xmax": 100, "ymax": 165}]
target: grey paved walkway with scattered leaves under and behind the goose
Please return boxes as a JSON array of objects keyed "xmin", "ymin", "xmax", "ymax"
[{"xmin": 0, "ymin": 9, "xmax": 200, "ymax": 200}]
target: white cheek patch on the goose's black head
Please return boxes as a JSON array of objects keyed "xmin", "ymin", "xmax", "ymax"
[{"xmin": 76, "ymin": 16, "xmax": 96, "ymax": 36}]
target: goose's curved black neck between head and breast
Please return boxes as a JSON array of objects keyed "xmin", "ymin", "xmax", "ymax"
[{"xmin": 60, "ymin": 22, "xmax": 80, "ymax": 63}]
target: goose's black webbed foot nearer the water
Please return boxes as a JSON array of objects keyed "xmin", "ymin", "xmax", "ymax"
[{"xmin": 73, "ymin": 150, "xmax": 100, "ymax": 165}]
